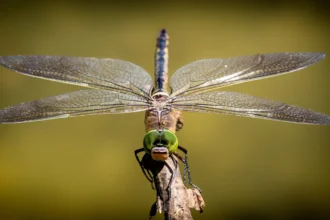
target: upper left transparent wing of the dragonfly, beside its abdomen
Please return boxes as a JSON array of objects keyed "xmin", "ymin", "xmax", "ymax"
[{"xmin": 0, "ymin": 56, "xmax": 152, "ymax": 97}]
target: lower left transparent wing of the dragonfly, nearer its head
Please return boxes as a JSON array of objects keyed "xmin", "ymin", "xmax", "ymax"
[{"xmin": 0, "ymin": 89, "xmax": 148, "ymax": 124}]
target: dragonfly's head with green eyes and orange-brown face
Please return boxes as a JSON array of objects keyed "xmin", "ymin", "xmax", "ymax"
[{"xmin": 143, "ymin": 130, "xmax": 179, "ymax": 161}]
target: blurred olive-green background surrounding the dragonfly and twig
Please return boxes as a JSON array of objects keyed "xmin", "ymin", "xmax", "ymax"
[{"xmin": 0, "ymin": 0, "xmax": 330, "ymax": 220}]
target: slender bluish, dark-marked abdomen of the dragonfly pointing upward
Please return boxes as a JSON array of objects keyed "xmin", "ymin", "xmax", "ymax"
[{"xmin": 154, "ymin": 29, "xmax": 169, "ymax": 94}]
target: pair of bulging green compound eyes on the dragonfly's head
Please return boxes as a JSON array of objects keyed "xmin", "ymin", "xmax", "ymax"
[{"xmin": 143, "ymin": 130, "xmax": 179, "ymax": 155}]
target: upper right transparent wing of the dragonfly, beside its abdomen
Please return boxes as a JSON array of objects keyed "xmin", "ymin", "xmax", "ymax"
[{"xmin": 170, "ymin": 53, "xmax": 325, "ymax": 97}]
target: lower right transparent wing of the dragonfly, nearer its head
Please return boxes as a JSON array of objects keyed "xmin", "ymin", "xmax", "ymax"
[{"xmin": 172, "ymin": 92, "xmax": 330, "ymax": 124}]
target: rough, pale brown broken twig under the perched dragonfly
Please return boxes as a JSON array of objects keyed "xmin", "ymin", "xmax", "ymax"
[{"xmin": 156, "ymin": 158, "xmax": 205, "ymax": 220}]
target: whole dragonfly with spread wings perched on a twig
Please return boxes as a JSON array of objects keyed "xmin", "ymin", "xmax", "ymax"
[{"xmin": 0, "ymin": 29, "xmax": 330, "ymax": 214}]
